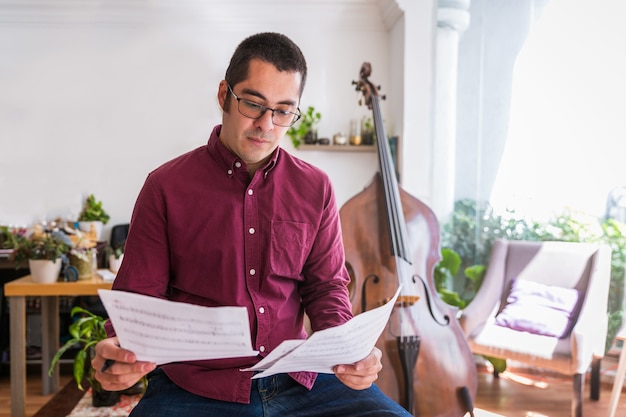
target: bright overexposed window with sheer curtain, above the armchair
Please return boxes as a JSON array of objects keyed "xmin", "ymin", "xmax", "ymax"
[{"xmin": 455, "ymin": 0, "xmax": 626, "ymax": 216}]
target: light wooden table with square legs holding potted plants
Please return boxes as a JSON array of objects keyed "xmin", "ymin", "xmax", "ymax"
[{"xmin": 4, "ymin": 275, "xmax": 113, "ymax": 417}]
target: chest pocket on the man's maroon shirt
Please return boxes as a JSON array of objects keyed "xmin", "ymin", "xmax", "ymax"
[{"xmin": 270, "ymin": 221, "xmax": 313, "ymax": 279}]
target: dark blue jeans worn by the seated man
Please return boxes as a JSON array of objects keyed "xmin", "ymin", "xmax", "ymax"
[{"xmin": 130, "ymin": 369, "xmax": 411, "ymax": 417}]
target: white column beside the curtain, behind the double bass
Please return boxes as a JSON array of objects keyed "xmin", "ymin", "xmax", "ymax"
[{"xmin": 432, "ymin": 0, "xmax": 470, "ymax": 222}]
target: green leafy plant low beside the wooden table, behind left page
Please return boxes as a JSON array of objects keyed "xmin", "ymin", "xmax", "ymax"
[{"xmin": 48, "ymin": 306, "xmax": 107, "ymax": 391}]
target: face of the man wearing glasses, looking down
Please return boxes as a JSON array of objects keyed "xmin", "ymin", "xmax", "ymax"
[{"xmin": 218, "ymin": 59, "xmax": 301, "ymax": 172}]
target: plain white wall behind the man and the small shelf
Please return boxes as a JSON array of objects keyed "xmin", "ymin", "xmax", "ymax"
[{"xmin": 0, "ymin": 0, "xmax": 432, "ymax": 236}]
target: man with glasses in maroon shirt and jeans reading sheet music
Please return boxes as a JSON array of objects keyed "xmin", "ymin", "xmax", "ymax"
[{"xmin": 92, "ymin": 33, "xmax": 409, "ymax": 417}]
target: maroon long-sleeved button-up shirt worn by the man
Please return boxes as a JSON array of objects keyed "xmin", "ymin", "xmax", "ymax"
[{"xmin": 108, "ymin": 126, "xmax": 352, "ymax": 403}]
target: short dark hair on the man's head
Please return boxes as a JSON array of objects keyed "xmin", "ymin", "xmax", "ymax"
[{"xmin": 224, "ymin": 32, "xmax": 307, "ymax": 96}]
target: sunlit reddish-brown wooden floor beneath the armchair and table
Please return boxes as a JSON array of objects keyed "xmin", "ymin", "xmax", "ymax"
[{"xmin": 0, "ymin": 358, "xmax": 626, "ymax": 417}]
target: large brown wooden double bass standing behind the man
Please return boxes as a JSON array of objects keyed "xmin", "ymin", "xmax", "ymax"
[{"xmin": 340, "ymin": 62, "xmax": 477, "ymax": 417}]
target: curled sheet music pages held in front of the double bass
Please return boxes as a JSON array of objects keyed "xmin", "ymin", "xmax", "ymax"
[{"xmin": 244, "ymin": 288, "xmax": 400, "ymax": 379}]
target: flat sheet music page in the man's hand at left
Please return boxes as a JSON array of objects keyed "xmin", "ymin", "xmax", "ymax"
[{"xmin": 98, "ymin": 290, "xmax": 258, "ymax": 365}]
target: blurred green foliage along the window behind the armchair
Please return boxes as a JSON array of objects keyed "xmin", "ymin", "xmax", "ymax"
[{"xmin": 435, "ymin": 199, "xmax": 626, "ymax": 351}]
